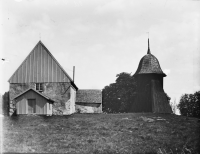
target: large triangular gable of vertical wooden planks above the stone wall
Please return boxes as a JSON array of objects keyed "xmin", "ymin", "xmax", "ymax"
[{"xmin": 9, "ymin": 41, "xmax": 72, "ymax": 83}]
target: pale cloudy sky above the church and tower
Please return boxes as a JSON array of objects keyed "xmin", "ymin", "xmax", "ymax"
[{"xmin": 0, "ymin": 0, "xmax": 200, "ymax": 110}]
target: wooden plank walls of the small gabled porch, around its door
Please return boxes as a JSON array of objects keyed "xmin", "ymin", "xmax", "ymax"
[{"xmin": 15, "ymin": 91, "xmax": 52, "ymax": 115}]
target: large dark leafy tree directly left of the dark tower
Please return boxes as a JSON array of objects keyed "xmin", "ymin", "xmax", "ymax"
[{"xmin": 102, "ymin": 72, "xmax": 136, "ymax": 113}]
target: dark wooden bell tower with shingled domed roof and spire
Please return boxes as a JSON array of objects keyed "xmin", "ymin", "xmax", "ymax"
[{"xmin": 131, "ymin": 39, "xmax": 172, "ymax": 113}]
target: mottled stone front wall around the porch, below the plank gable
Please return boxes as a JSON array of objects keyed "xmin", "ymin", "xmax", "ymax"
[{"xmin": 10, "ymin": 82, "xmax": 70, "ymax": 115}]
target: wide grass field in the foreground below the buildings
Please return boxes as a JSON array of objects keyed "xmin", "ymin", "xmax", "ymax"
[{"xmin": 1, "ymin": 113, "xmax": 200, "ymax": 154}]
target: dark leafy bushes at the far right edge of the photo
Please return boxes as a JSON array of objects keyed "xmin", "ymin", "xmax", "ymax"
[{"xmin": 178, "ymin": 91, "xmax": 200, "ymax": 118}]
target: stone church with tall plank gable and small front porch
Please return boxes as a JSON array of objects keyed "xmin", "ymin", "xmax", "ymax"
[{"xmin": 9, "ymin": 41, "xmax": 78, "ymax": 115}]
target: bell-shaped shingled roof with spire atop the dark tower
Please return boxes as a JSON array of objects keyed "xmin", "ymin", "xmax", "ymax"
[{"xmin": 134, "ymin": 39, "xmax": 166, "ymax": 77}]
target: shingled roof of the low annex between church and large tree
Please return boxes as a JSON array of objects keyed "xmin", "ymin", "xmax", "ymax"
[{"xmin": 76, "ymin": 89, "xmax": 102, "ymax": 103}]
